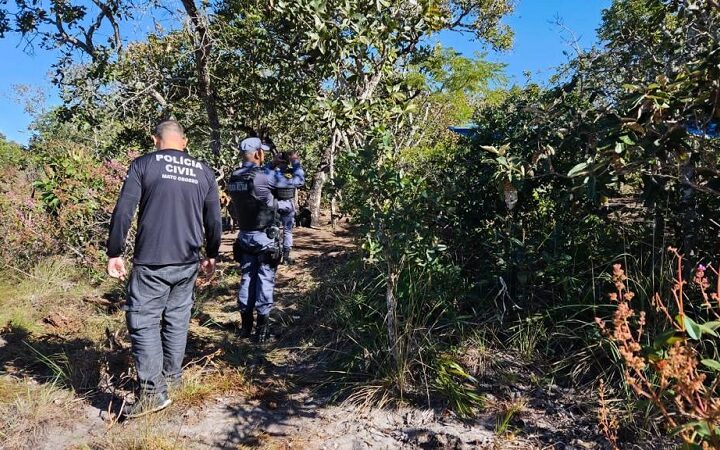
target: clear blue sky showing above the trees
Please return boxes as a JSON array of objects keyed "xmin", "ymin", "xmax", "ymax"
[{"xmin": 0, "ymin": 0, "xmax": 611, "ymax": 143}]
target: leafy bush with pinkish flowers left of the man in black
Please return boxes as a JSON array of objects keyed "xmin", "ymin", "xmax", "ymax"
[{"xmin": 0, "ymin": 128, "xmax": 132, "ymax": 269}]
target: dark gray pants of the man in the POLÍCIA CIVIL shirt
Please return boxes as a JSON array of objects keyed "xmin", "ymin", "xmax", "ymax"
[{"xmin": 124, "ymin": 262, "xmax": 198, "ymax": 394}]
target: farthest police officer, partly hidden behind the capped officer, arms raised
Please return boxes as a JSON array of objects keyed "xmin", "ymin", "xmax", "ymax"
[{"xmin": 271, "ymin": 151, "xmax": 305, "ymax": 265}]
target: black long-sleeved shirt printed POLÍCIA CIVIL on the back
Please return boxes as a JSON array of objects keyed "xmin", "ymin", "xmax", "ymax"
[{"xmin": 107, "ymin": 149, "xmax": 222, "ymax": 265}]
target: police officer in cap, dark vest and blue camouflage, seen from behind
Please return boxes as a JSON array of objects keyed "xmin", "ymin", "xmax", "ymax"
[{"xmin": 228, "ymin": 137, "xmax": 303, "ymax": 343}]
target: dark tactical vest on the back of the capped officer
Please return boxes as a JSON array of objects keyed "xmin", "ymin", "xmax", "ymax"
[{"xmin": 228, "ymin": 167, "xmax": 275, "ymax": 231}]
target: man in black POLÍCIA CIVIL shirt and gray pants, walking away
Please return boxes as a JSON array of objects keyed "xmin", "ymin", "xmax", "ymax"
[{"xmin": 107, "ymin": 120, "xmax": 222, "ymax": 418}]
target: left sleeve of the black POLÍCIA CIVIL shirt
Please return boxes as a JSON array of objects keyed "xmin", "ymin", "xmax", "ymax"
[{"xmin": 107, "ymin": 160, "xmax": 142, "ymax": 258}]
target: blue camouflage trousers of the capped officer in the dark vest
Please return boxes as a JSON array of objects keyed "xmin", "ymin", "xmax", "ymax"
[{"xmin": 238, "ymin": 231, "xmax": 277, "ymax": 315}]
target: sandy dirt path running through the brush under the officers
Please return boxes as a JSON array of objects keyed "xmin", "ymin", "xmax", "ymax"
[{"xmin": 8, "ymin": 220, "xmax": 620, "ymax": 450}]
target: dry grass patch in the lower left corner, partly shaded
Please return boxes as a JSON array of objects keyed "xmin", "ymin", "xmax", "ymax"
[{"xmin": 0, "ymin": 258, "xmax": 125, "ymax": 448}]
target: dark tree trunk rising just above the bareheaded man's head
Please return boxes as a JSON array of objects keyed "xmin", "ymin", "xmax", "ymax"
[{"xmin": 182, "ymin": 0, "xmax": 221, "ymax": 156}]
